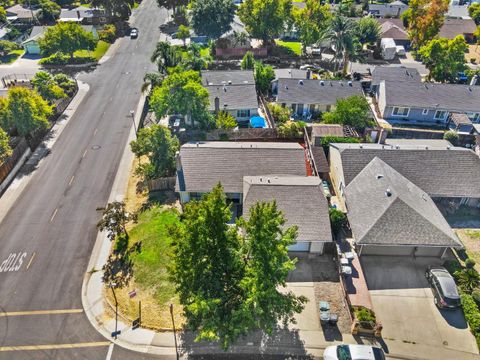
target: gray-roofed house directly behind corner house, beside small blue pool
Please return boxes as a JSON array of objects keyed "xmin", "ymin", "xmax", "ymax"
[{"xmin": 202, "ymin": 70, "xmax": 258, "ymax": 123}]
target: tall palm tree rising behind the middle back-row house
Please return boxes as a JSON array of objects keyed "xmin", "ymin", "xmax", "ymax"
[{"xmin": 321, "ymin": 16, "xmax": 358, "ymax": 76}]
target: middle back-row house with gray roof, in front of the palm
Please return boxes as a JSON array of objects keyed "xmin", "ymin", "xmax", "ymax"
[{"xmin": 274, "ymin": 79, "xmax": 363, "ymax": 117}]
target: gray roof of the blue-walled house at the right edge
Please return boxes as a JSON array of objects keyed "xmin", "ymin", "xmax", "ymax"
[{"xmin": 385, "ymin": 81, "xmax": 480, "ymax": 112}]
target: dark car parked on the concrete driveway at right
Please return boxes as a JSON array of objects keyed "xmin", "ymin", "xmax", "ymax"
[{"xmin": 425, "ymin": 266, "xmax": 460, "ymax": 309}]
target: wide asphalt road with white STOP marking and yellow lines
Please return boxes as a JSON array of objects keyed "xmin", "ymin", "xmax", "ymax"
[{"xmin": 0, "ymin": 0, "xmax": 171, "ymax": 360}]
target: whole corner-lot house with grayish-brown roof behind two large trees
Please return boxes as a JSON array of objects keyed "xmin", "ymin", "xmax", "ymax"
[{"xmin": 176, "ymin": 142, "xmax": 331, "ymax": 252}]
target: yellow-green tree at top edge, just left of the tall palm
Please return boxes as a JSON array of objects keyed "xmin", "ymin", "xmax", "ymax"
[{"xmin": 293, "ymin": 0, "xmax": 333, "ymax": 50}]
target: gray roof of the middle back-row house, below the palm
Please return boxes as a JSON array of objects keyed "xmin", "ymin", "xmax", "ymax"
[{"xmin": 277, "ymin": 79, "xmax": 363, "ymax": 105}]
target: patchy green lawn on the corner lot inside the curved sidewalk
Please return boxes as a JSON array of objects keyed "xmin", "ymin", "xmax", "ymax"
[{"xmin": 130, "ymin": 206, "xmax": 180, "ymax": 305}]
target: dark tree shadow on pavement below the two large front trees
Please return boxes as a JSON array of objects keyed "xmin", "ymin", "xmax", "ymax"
[{"xmin": 179, "ymin": 329, "xmax": 313, "ymax": 360}]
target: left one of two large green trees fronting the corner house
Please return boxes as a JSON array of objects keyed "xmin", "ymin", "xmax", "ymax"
[{"xmin": 169, "ymin": 185, "xmax": 244, "ymax": 346}]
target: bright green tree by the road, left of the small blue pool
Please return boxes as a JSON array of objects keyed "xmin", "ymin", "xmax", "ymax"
[{"xmin": 150, "ymin": 70, "xmax": 213, "ymax": 128}]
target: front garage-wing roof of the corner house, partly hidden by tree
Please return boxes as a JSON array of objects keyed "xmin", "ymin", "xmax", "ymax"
[{"xmin": 243, "ymin": 175, "xmax": 332, "ymax": 241}]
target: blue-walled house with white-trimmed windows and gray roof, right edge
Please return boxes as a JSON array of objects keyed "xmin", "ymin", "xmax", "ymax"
[{"xmin": 377, "ymin": 81, "xmax": 480, "ymax": 126}]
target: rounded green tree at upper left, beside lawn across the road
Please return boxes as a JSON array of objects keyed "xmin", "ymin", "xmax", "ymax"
[{"xmin": 39, "ymin": 22, "xmax": 97, "ymax": 58}]
